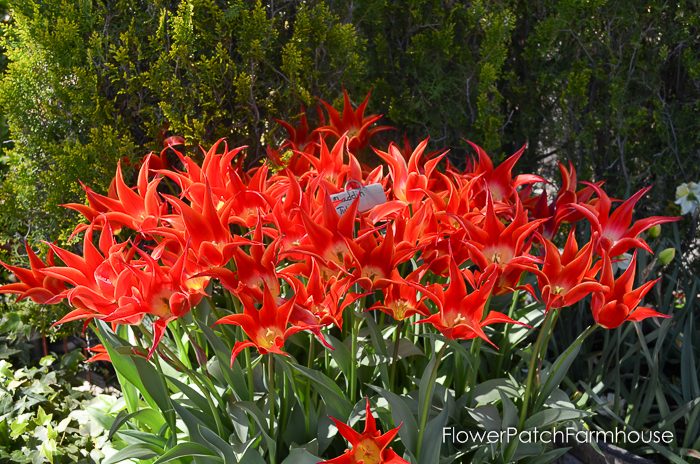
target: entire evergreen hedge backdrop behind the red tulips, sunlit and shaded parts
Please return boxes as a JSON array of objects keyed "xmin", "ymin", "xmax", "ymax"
[{"xmin": 0, "ymin": 0, "xmax": 700, "ymax": 249}]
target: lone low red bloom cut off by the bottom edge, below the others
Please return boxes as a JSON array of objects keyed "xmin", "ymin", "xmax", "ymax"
[{"xmin": 318, "ymin": 398, "xmax": 409, "ymax": 464}]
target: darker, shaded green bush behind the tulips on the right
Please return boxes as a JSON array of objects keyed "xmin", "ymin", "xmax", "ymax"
[{"xmin": 348, "ymin": 0, "xmax": 700, "ymax": 203}]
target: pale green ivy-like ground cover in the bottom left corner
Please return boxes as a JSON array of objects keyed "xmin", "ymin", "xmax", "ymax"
[{"xmin": 0, "ymin": 351, "xmax": 124, "ymax": 464}]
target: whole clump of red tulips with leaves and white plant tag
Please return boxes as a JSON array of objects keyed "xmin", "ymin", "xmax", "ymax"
[{"xmin": 0, "ymin": 94, "xmax": 676, "ymax": 464}]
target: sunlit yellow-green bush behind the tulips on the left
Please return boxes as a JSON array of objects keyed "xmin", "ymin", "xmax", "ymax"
[{"xmin": 0, "ymin": 0, "xmax": 368, "ymax": 249}]
